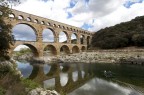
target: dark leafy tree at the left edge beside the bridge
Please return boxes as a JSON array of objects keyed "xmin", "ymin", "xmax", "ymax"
[{"xmin": 0, "ymin": 0, "xmax": 13, "ymax": 59}]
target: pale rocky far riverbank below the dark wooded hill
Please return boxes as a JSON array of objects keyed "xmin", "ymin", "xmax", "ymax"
[{"xmin": 51, "ymin": 48, "xmax": 144, "ymax": 63}]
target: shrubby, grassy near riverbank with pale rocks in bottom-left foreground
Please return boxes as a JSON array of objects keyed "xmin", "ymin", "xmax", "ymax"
[{"xmin": 0, "ymin": 60, "xmax": 60, "ymax": 95}]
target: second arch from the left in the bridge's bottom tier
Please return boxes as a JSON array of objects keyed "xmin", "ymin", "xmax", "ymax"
[{"xmin": 44, "ymin": 45, "xmax": 58, "ymax": 56}]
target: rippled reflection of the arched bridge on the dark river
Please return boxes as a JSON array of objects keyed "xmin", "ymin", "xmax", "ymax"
[{"xmin": 18, "ymin": 64, "xmax": 94, "ymax": 93}]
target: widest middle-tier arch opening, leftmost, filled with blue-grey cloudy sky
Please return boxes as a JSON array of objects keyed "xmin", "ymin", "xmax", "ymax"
[{"xmin": 12, "ymin": 24, "xmax": 36, "ymax": 41}]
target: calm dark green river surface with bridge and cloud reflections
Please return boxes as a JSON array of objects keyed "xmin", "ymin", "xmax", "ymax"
[{"xmin": 17, "ymin": 61, "xmax": 144, "ymax": 95}]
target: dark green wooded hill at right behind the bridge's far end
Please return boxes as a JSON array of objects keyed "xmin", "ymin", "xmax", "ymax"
[{"xmin": 91, "ymin": 16, "xmax": 144, "ymax": 49}]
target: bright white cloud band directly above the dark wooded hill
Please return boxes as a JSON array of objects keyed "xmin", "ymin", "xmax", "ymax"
[{"xmin": 91, "ymin": 0, "xmax": 144, "ymax": 31}]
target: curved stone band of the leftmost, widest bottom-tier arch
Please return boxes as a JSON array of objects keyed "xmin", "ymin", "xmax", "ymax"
[{"xmin": 11, "ymin": 43, "xmax": 39, "ymax": 57}]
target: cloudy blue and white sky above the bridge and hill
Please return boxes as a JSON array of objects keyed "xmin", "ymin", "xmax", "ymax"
[{"xmin": 13, "ymin": 0, "xmax": 144, "ymax": 32}]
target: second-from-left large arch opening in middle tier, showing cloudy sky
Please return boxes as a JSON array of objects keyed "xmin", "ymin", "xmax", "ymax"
[{"xmin": 42, "ymin": 29, "xmax": 55, "ymax": 42}]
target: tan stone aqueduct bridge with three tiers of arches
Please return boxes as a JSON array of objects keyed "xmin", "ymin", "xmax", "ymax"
[{"xmin": 5, "ymin": 10, "xmax": 93, "ymax": 57}]
